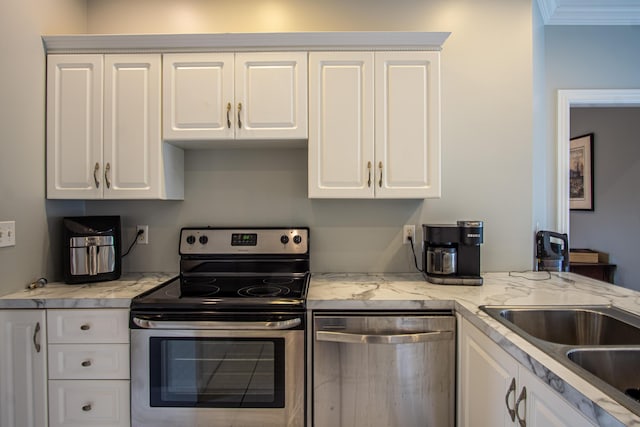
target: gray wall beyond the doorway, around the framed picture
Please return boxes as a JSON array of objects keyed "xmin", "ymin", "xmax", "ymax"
[{"xmin": 570, "ymin": 108, "xmax": 640, "ymax": 290}]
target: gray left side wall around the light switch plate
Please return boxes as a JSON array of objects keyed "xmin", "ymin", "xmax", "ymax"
[{"xmin": 0, "ymin": 0, "xmax": 86, "ymax": 293}]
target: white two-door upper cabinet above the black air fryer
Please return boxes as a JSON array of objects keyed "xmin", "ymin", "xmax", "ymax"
[{"xmin": 47, "ymin": 54, "xmax": 184, "ymax": 199}]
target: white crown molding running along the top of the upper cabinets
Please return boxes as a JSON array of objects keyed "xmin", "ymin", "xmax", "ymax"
[{"xmin": 42, "ymin": 32, "xmax": 451, "ymax": 53}]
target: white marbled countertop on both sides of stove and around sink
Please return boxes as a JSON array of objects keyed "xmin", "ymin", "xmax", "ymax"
[{"xmin": 0, "ymin": 272, "xmax": 640, "ymax": 427}]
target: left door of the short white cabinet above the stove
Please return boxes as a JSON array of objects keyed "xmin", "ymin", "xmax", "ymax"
[{"xmin": 162, "ymin": 53, "xmax": 236, "ymax": 141}]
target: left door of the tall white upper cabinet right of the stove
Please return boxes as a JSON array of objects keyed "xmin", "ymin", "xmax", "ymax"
[{"xmin": 309, "ymin": 52, "xmax": 375, "ymax": 198}]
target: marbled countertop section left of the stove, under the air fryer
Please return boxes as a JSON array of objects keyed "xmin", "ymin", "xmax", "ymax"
[{"xmin": 0, "ymin": 273, "xmax": 177, "ymax": 309}]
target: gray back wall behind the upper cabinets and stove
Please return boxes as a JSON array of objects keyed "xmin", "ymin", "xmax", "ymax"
[{"xmin": 87, "ymin": 0, "xmax": 533, "ymax": 272}]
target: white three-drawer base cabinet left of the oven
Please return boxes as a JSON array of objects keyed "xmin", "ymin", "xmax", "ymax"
[{"xmin": 47, "ymin": 309, "xmax": 130, "ymax": 427}]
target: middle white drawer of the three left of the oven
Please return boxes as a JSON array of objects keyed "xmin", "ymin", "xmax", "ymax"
[{"xmin": 49, "ymin": 344, "xmax": 129, "ymax": 380}]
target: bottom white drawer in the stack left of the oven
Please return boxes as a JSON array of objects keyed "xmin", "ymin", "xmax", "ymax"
[{"xmin": 49, "ymin": 380, "xmax": 130, "ymax": 427}]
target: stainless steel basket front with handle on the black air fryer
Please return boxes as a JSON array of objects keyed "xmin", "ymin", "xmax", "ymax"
[{"xmin": 69, "ymin": 236, "xmax": 116, "ymax": 276}]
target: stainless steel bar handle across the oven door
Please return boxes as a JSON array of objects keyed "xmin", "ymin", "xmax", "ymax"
[{"xmin": 132, "ymin": 317, "xmax": 302, "ymax": 330}]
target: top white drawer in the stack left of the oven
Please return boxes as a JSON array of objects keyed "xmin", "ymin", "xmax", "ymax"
[{"xmin": 47, "ymin": 309, "xmax": 129, "ymax": 344}]
